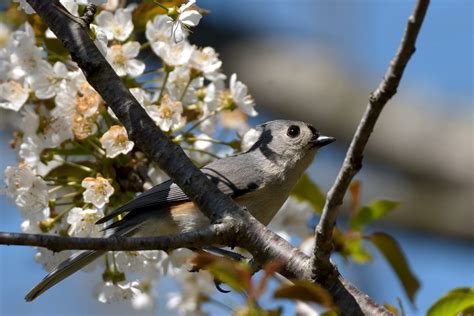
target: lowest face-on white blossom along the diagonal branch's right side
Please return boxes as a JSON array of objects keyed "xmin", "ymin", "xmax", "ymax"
[{"xmin": 146, "ymin": 95, "xmax": 183, "ymax": 132}]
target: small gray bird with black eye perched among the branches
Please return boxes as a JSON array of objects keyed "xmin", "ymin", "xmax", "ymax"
[{"xmin": 25, "ymin": 120, "xmax": 335, "ymax": 301}]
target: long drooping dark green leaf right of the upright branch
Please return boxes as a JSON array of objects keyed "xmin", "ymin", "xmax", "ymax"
[{"xmin": 369, "ymin": 233, "xmax": 420, "ymax": 304}]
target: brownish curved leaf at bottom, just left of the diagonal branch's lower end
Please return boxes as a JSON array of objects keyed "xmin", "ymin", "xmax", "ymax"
[{"xmin": 273, "ymin": 280, "xmax": 334, "ymax": 308}]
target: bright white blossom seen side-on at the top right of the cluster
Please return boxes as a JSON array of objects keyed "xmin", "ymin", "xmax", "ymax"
[{"xmin": 168, "ymin": 0, "xmax": 202, "ymax": 43}]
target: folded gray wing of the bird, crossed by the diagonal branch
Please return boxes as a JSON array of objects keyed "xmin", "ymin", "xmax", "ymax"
[{"xmin": 97, "ymin": 155, "xmax": 263, "ymax": 224}]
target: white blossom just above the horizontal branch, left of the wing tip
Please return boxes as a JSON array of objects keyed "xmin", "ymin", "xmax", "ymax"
[{"xmin": 66, "ymin": 207, "xmax": 104, "ymax": 237}]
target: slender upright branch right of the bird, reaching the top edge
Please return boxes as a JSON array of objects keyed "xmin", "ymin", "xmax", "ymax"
[{"xmin": 313, "ymin": 0, "xmax": 429, "ymax": 283}]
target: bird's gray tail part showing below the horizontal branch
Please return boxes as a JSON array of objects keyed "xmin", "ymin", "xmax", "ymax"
[{"xmin": 25, "ymin": 250, "xmax": 105, "ymax": 302}]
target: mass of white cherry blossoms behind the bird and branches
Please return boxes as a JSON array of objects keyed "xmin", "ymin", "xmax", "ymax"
[{"xmin": 0, "ymin": 0, "xmax": 310, "ymax": 313}]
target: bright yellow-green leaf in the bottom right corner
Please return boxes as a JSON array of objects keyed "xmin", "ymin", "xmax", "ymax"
[{"xmin": 427, "ymin": 287, "xmax": 474, "ymax": 316}]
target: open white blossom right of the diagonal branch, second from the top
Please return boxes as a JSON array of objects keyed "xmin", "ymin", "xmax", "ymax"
[{"xmin": 107, "ymin": 42, "xmax": 145, "ymax": 77}]
